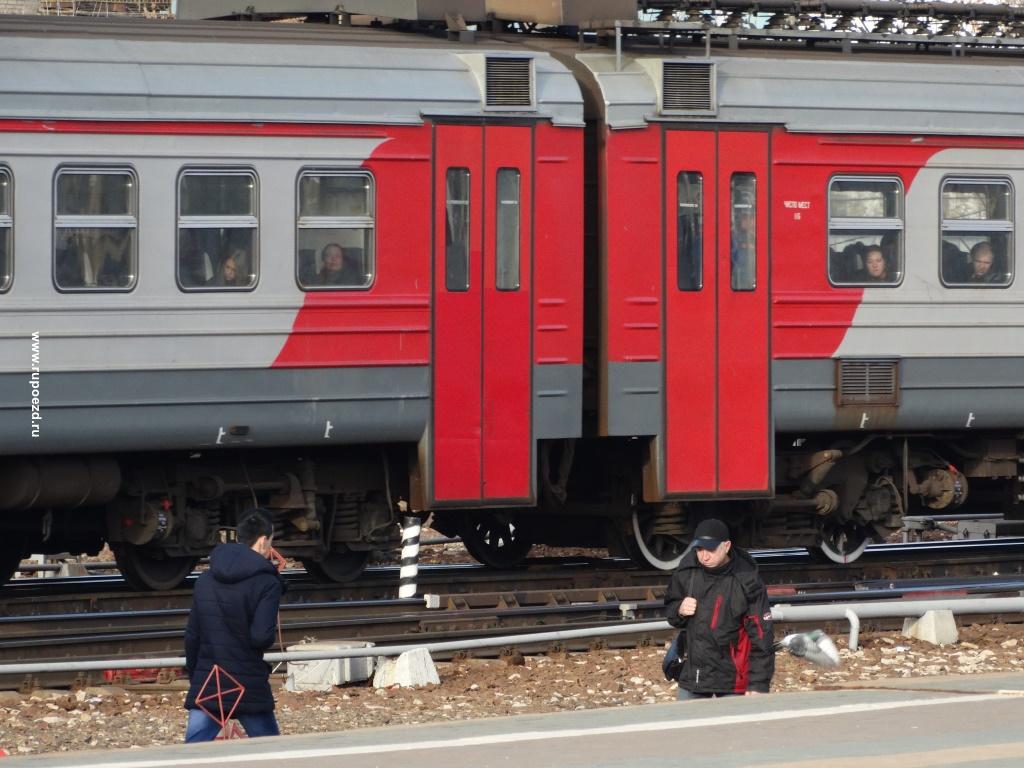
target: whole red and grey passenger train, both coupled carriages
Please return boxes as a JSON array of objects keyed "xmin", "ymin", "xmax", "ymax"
[{"xmin": 0, "ymin": 13, "xmax": 1024, "ymax": 588}]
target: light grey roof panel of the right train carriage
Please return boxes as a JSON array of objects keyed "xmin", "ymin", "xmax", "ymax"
[{"xmin": 577, "ymin": 51, "xmax": 1024, "ymax": 136}]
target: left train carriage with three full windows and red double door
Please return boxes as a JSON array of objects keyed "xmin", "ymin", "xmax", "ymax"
[{"xmin": 0, "ymin": 19, "xmax": 583, "ymax": 589}]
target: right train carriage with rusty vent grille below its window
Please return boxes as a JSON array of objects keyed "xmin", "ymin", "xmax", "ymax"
[{"xmin": 577, "ymin": 46, "xmax": 1024, "ymax": 567}]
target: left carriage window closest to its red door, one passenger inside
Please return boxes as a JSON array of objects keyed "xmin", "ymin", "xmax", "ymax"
[{"xmin": 296, "ymin": 170, "xmax": 375, "ymax": 291}]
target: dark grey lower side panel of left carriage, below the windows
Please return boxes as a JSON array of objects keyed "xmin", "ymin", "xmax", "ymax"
[{"xmin": 0, "ymin": 366, "xmax": 430, "ymax": 455}]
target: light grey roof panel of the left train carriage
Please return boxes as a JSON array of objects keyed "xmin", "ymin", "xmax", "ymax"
[{"xmin": 0, "ymin": 20, "xmax": 583, "ymax": 126}]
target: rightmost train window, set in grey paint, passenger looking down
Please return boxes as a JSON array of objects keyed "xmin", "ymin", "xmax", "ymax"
[{"xmin": 939, "ymin": 178, "xmax": 1014, "ymax": 288}]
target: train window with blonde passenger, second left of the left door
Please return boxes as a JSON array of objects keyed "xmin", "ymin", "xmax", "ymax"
[{"xmin": 177, "ymin": 168, "xmax": 259, "ymax": 291}]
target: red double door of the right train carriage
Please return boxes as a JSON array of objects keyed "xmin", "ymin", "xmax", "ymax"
[{"xmin": 664, "ymin": 131, "xmax": 772, "ymax": 498}]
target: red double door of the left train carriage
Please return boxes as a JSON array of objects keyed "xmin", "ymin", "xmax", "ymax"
[{"xmin": 430, "ymin": 125, "xmax": 534, "ymax": 506}]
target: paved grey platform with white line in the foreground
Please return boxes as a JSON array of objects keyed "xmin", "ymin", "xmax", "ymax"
[{"xmin": 8, "ymin": 673, "xmax": 1024, "ymax": 768}]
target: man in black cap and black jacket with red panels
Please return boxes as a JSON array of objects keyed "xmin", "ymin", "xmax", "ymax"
[{"xmin": 665, "ymin": 519, "xmax": 775, "ymax": 700}]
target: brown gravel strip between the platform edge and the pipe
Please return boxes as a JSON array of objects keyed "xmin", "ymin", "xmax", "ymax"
[{"xmin": 0, "ymin": 625, "xmax": 1024, "ymax": 755}]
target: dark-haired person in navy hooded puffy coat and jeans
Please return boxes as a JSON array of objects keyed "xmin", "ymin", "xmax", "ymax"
[{"xmin": 185, "ymin": 509, "xmax": 285, "ymax": 742}]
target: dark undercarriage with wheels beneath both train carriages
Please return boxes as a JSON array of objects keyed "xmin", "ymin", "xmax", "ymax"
[{"xmin": 0, "ymin": 434, "xmax": 1024, "ymax": 590}]
